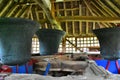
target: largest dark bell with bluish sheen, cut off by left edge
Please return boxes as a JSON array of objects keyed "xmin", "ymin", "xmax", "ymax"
[{"xmin": 0, "ymin": 18, "xmax": 39, "ymax": 65}]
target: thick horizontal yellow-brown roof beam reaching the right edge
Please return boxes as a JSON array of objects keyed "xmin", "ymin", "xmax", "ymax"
[{"xmin": 57, "ymin": 16, "xmax": 120, "ymax": 23}]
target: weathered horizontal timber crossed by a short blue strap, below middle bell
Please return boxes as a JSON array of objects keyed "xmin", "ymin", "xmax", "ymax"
[{"xmin": 36, "ymin": 60, "xmax": 88, "ymax": 72}]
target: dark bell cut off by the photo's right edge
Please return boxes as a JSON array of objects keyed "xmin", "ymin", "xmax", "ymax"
[{"xmin": 93, "ymin": 27, "xmax": 120, "ymax": 60}]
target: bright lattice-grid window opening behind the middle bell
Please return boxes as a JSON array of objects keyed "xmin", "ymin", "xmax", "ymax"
[{"xmin": 32, "ymin": 37, "xmax": 99, "ymax": 54}]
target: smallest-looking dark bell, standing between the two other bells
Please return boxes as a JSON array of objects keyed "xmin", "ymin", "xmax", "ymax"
[{"xmin": 36, "ymin": 29, "xmax": 65, "ymax": 55}]
